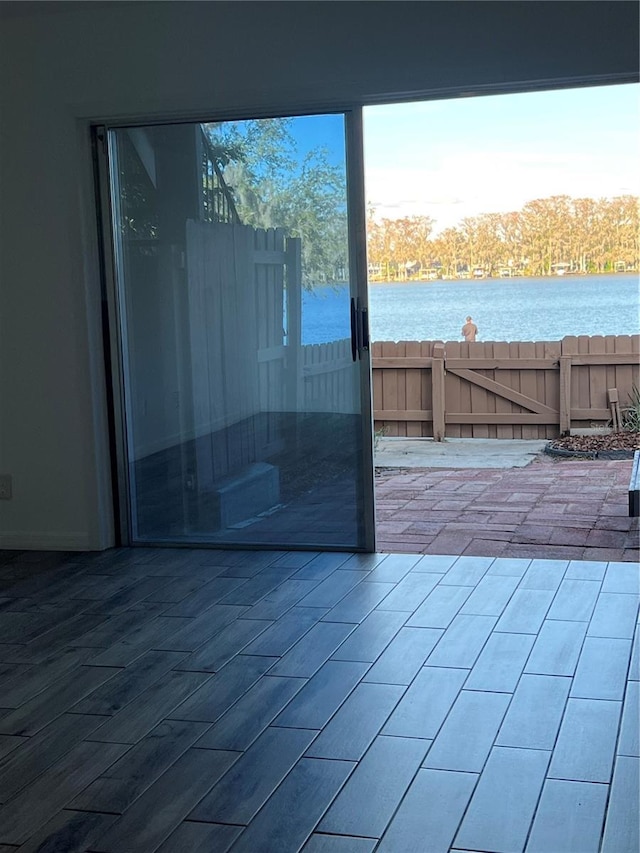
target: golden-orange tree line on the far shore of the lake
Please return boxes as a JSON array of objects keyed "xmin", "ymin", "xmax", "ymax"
[{"xmin": 367, "ymin": 195, "xmax": 640, "ymax": 281}]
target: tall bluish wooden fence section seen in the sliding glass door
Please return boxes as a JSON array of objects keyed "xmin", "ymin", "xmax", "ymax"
[{"xmin": 186, "ymin": 222, "xmax": 301, "ymax": 489}]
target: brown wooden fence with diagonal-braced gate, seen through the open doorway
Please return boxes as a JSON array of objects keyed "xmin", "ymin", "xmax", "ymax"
[{"xmin": 372, "ymin": 335, "xmax": 640, "ymax": 439}]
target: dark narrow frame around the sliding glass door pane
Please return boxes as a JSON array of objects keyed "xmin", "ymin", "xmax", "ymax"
[{"xmin": 90, "ymin": 104, "xmax": 376, "ymax": 553}]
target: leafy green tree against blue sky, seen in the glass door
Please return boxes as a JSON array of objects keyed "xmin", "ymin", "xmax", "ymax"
[{"xmin": 203, "ymin": 118, "xmax": 347, "ymax": 287}]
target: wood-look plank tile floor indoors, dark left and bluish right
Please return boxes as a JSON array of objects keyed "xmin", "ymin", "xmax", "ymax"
[{"xmin": 0, "ymin": 548, "xmax": 640, "ymax": 853}]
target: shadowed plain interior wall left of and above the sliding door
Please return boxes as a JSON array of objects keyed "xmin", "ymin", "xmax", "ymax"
[{"xmin": 0, "ymin": 0, "xmax": 638, "ymax": 548}]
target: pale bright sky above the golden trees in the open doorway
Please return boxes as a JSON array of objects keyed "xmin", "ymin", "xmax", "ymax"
[{"xmin": 364, "ymin": 84, "xmax": 640, "ymax": 233}]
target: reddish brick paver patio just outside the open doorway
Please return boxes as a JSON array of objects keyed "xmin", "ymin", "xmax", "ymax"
[{"xmin": 376, "ymin": 456, "xmax": 639, "ymax": 561}]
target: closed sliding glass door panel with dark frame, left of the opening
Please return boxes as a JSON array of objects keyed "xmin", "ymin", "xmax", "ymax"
[{"xmin": 107, "ymin": 114, "xmax": 374, "ymax": 550}]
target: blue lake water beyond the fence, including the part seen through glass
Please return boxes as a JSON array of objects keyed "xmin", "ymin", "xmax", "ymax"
[{"xmin": 302, "ymin": 274, "xmax": 640, "ymax": 344}]
